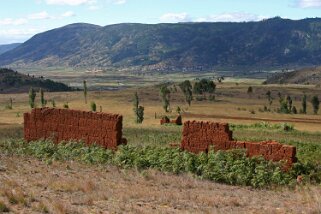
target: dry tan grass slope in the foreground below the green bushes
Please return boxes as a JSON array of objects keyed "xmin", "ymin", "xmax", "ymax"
[{"xmin": 0, "ymin": 153, "xmax": 321, "ymax": 213}]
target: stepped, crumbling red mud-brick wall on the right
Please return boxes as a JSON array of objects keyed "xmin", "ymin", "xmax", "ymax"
[{"xmin": 181, "ymin": 121, "xmax": 297, "ymax": 170}]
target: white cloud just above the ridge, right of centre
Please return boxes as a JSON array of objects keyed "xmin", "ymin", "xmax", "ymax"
[{"xmin": 194, "ymin": 12, "xmax": 267, "ymax": 22}]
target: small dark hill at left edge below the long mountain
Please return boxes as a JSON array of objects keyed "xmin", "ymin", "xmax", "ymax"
[{"xmin": 0, "ymin": 68, "xmax": 73, "ymax": 93}]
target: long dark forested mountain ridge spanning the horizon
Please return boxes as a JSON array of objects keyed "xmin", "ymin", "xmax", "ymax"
[{"xmin": 0, "ymin": 17, "xmax": 321, "ymax": 71}]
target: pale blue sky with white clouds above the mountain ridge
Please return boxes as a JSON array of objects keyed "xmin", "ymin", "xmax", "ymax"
[{"xmin": 0, "ymin": 0, "xmax": 321, "ymax": 44}]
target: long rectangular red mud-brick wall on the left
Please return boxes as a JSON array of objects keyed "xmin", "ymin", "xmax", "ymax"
[{"xmin": 24, "ymin": 108, "xmax": 126, "ymax": 149}]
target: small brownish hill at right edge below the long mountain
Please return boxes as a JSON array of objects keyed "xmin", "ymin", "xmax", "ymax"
[{"xmin": 265, "ymin": 67, "xmax": 321, "ymax": 85}]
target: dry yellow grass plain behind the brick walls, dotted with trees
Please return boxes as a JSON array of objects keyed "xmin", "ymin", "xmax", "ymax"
[{"xmin": 0, "ymin": 82, "xmax": 321, "ymax": 131}]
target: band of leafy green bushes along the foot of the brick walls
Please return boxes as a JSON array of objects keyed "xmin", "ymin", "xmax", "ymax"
[{"xmin": 0, "ymin": 141, "xmax": 320, "ymax": 188}]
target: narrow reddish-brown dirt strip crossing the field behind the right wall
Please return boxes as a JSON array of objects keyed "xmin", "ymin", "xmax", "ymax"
[{"xmin": 182, "ymin": 113, "xmax": 321, "ymax": 125}]
